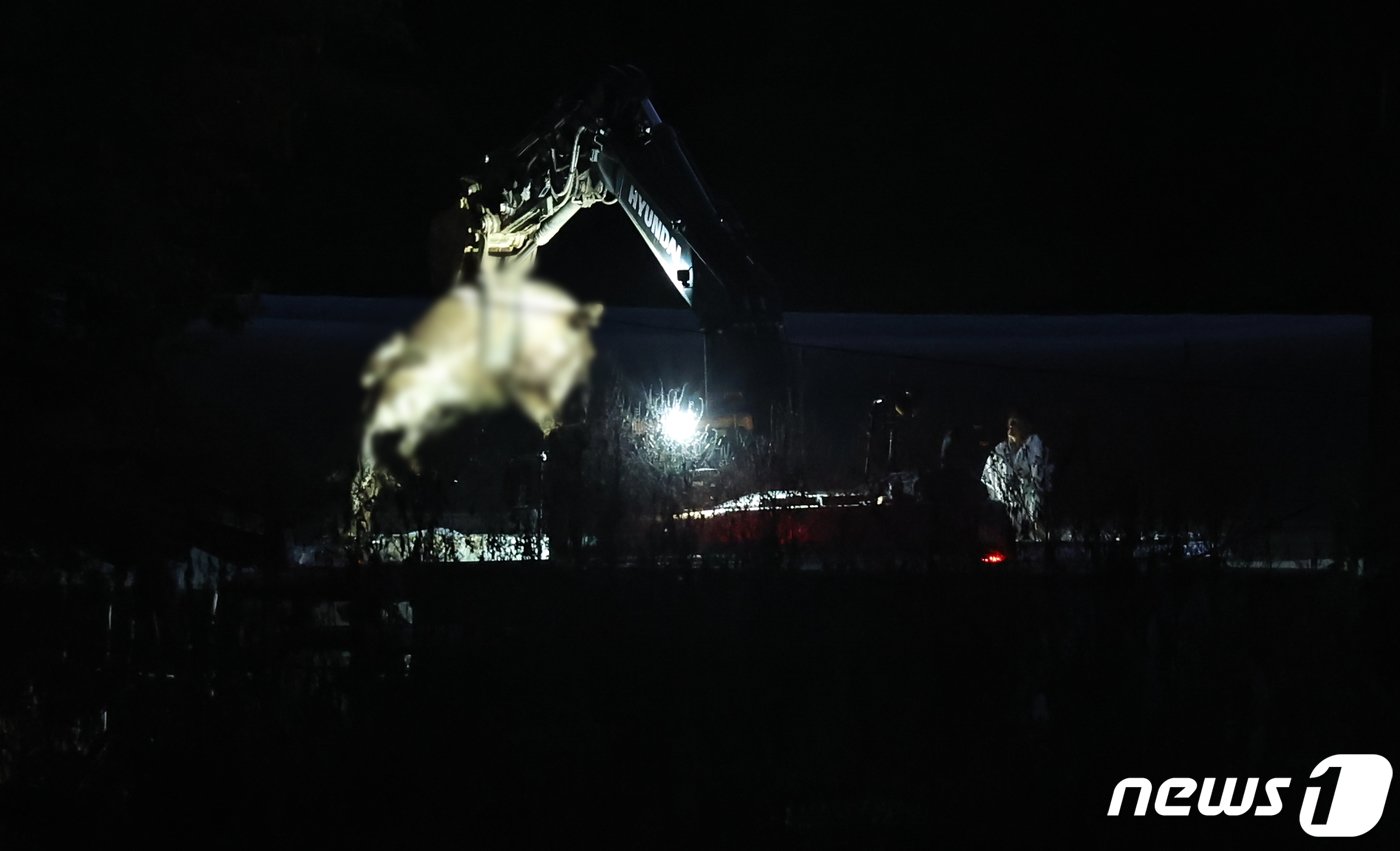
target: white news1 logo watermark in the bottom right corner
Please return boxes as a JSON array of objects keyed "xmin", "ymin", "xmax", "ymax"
[{"xmin": 1109, "ymin": 753, "xmax": 1392, "ymax": 837}]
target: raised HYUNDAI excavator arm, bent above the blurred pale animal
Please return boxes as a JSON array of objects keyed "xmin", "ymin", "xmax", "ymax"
[{"xmin": 433, "ymin": 66, "xmax": 784, "ymax": 430}]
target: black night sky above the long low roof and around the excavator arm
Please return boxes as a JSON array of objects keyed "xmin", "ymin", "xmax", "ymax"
[{"xmin": 4, "ymin": 0, "xmax": 1397, "ymax": 312}]
